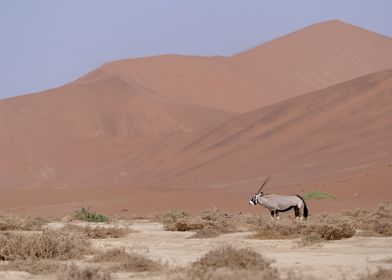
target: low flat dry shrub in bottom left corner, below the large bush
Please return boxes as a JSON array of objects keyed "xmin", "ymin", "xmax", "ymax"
[{"xmin": 0, "ymin": 260, "xmax": 62, "ymax": 274}]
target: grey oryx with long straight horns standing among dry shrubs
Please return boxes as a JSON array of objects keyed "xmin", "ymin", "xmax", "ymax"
[{"xmin": 249, "ymin": 176, "xmax": 308, "ymax": 220}]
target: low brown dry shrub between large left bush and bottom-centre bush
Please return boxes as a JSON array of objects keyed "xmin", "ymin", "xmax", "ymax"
[{"xmin": 92, "ymin": 249, "xmax": 164, "ymax": 272}]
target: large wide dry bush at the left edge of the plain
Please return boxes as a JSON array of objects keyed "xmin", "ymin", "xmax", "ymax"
[{"xmin": 0, "ymin": 230, "xmax": 90, "ymax": 261}]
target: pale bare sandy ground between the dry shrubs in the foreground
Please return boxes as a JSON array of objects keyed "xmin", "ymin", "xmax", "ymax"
[{"xmin": 0, "ymin": 220, "xmax": 392, "ymax": 280}]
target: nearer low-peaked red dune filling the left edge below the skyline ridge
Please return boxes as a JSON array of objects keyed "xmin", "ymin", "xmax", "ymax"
[{"xmin": 0, "ymin": 73, "xmax": 232, "ymax": 189}]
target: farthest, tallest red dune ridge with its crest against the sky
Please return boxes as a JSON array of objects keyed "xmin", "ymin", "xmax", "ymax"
[{"xmin": 83, "ymin": 21, "xmax": 392, "ymax": 112}]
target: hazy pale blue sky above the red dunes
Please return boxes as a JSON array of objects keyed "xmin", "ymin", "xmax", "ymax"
[{"xmin": 0, "ymin": 0, "xmax": 392, "ymax": 98}]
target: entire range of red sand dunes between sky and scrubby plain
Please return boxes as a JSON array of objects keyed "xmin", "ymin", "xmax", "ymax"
[{"xmin": 0, "ymin": 21, "xmax": 392, "ymax": 214}]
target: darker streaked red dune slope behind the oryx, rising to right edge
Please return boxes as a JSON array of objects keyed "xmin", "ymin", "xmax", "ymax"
[{"xmin": 132, "ymin": 70, "xmax": 392, "ymax": 206}]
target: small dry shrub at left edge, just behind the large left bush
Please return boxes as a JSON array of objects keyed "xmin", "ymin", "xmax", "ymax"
[{"xmin": 0, "ymin": 213, "xmax": 50, "ymax": 231}]
